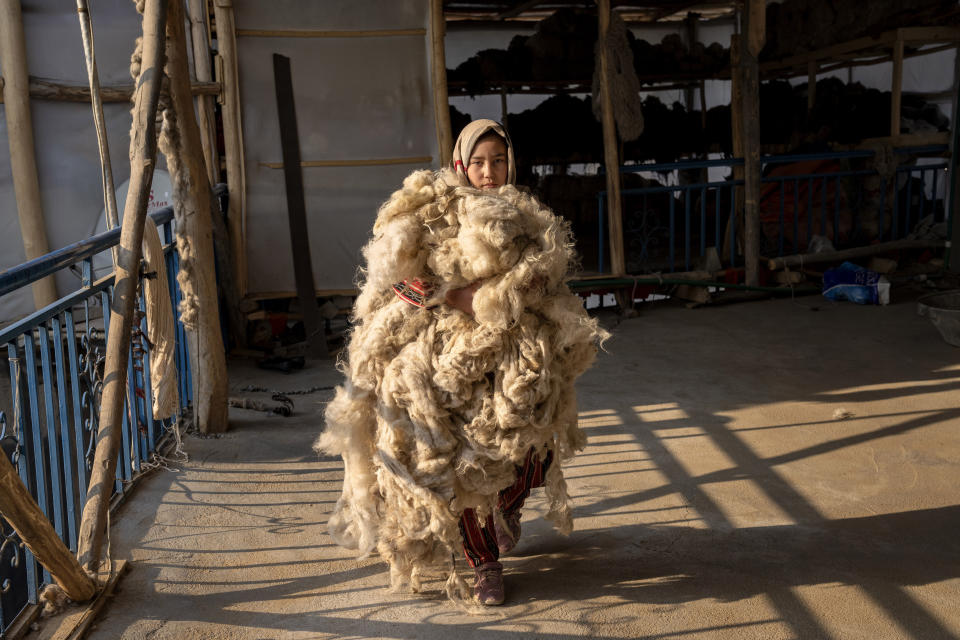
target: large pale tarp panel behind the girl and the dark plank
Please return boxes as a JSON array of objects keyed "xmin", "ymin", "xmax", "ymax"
[{"xmin": 234, "ymin": 0, "xmax": 439, "ymax": 295}]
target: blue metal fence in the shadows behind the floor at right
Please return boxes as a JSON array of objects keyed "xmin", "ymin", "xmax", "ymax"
[{"xmin": 597, "ymin": 145, "xmax": 949, "ymax": 273}]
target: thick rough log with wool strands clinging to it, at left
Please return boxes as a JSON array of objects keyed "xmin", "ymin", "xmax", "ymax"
[{"xmin": 163, "ymin": 0, "xmax": 227, "ymax": 433}]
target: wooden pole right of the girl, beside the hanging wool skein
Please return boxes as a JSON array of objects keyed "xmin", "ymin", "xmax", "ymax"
[{"xmin": 597, "ymin": 0, "xmax": 627, "ymax": 276}]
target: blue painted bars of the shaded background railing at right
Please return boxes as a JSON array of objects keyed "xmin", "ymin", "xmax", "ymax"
[{"xmin": 597, "ymin": 145, "xmax": 948, "ymax": 273}]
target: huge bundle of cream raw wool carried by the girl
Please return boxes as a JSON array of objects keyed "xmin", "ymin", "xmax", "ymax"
[{"xmin": 316, "ymin": 170, "xmax": 608, "ymax": 599}]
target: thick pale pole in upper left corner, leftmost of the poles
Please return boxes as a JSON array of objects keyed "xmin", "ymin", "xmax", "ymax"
[{"xmin": 0, "ymin": 0, "xmax": 57, "ymax": 309}]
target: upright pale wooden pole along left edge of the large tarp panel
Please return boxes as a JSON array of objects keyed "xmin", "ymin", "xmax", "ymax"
[{"xmin": 213, "ymin": 0, "xmax": 247, "ymax": 297}]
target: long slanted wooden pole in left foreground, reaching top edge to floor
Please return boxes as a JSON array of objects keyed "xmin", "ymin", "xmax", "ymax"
[{"xmin": 77, "ymin": 0, "xmax": 167, "ymax": 571}]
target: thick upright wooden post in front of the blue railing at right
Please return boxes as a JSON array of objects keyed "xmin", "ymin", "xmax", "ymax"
[{"xmin": 740, "ymin": 0, "xmax": 766, "ymax": 287}]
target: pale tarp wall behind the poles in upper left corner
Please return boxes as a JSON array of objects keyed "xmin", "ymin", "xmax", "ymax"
[{"xmin": 0, "ymin": 0, "xmax": 141, "ymax": 322}]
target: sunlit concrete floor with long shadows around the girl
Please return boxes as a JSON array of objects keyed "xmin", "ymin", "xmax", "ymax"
[{"xmin": 54, "ymin": 297, "xmax": 960, "ymax": 640}]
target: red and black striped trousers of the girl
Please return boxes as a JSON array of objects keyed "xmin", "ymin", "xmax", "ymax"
[{"xmin": 460, "ymin": 448, "xmax": 553, "ymax": 568}]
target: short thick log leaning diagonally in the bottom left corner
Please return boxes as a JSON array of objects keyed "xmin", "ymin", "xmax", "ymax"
[{"xmin": 0, "ymin": 452, "xmax": 97, "ymax": 602}]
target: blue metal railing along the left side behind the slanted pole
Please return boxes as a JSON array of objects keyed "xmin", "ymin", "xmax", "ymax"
[{"xmin": 0, "ymin": 186, "xmax": 219, "ymax": 633}]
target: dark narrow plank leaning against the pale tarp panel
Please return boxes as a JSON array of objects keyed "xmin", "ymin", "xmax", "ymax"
[{"xmin": 273, "ymin": 53, "xmax": 329, "ymax": 357}]
